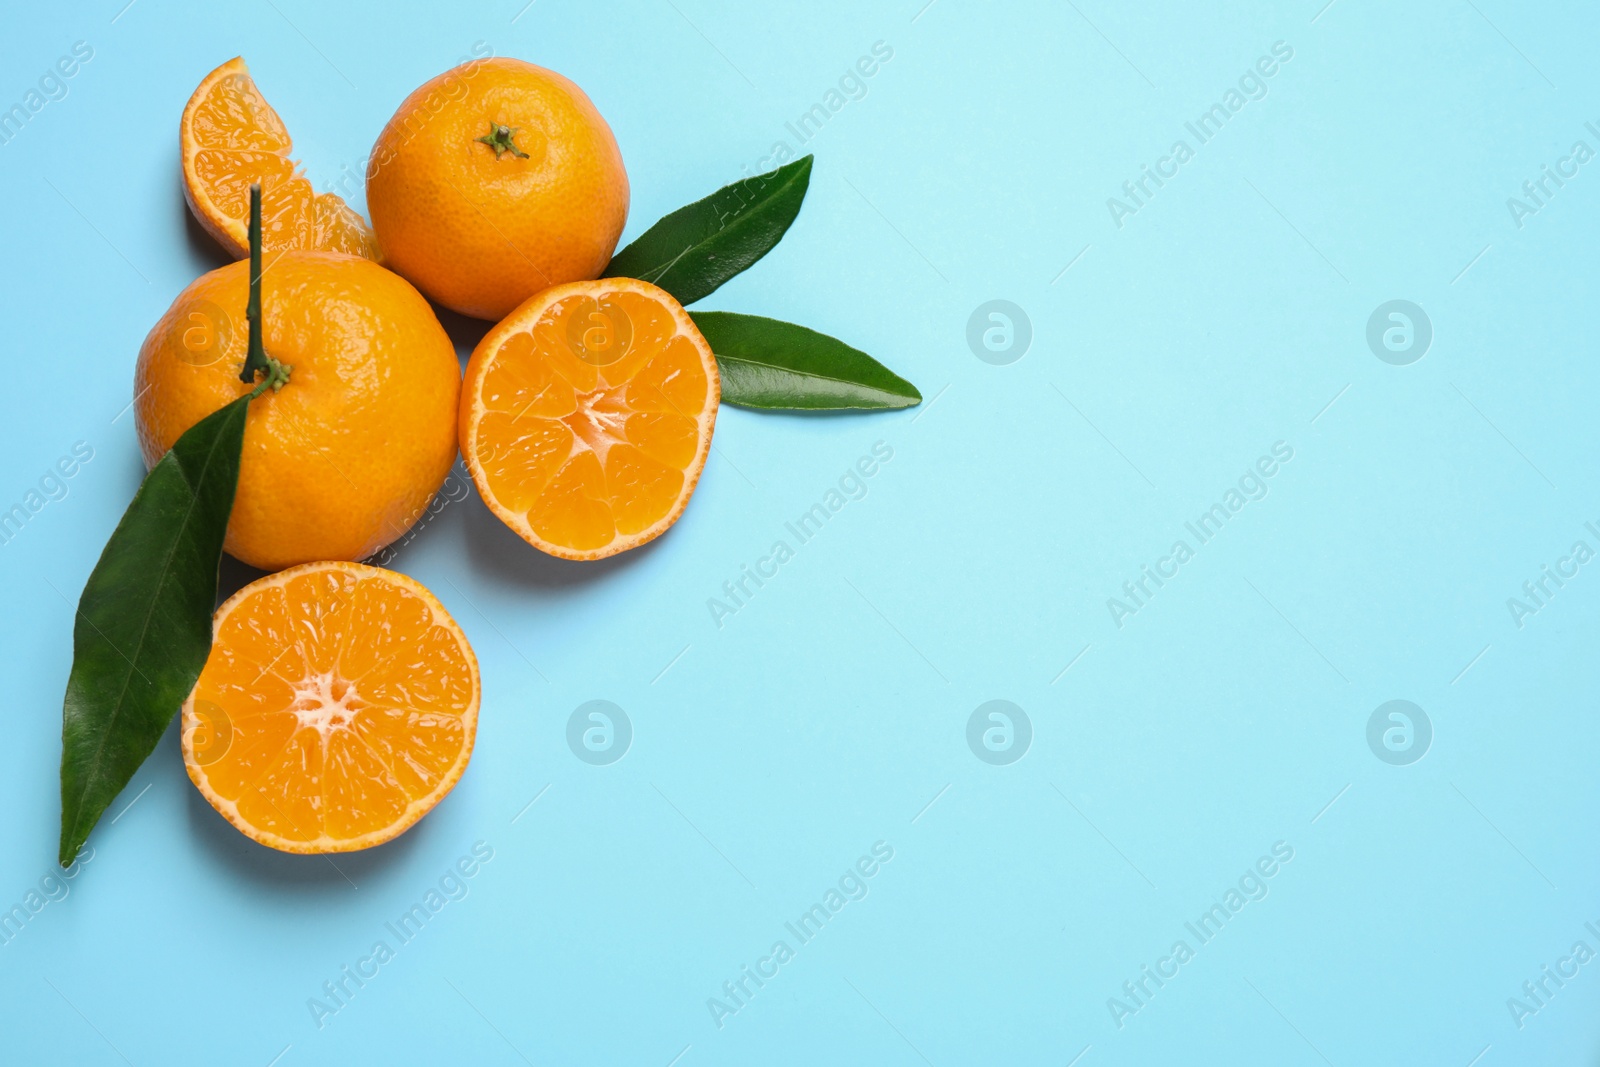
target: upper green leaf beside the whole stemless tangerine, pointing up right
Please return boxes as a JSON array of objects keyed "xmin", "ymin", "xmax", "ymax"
[{"xmin": 603, "ymin": 155, "xmax": 811, "ymax": 304}]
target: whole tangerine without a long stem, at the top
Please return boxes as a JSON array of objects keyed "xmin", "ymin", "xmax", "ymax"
[{"xmin": 366, "ymin": 58, "xmax": 627, "ymax": 320}]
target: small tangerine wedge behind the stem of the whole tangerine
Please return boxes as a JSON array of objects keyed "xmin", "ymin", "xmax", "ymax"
[{"xmin": 179, "ymin": 58, "xmax": 379, "ymax": 259}]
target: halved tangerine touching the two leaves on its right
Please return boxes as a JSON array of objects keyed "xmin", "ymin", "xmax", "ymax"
[{"xmin": 461, "ymin": 278, "xmax": 722, "ymax": 560}]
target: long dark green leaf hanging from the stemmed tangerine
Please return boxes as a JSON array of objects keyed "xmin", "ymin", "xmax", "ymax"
[{"xmin": 59, "ymin": 389, "xmax": 249, "ymax": 867}]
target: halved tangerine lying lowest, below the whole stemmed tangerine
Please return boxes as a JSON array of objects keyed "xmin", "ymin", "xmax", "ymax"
[{"xmin": 182, "ymin": 563, "xmax": 480, "ymax": 853}]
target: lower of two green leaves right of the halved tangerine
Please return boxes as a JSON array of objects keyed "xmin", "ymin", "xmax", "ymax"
[{"xmin": 691, "ymin": 312, "xmax": 922, "ymax": 411}]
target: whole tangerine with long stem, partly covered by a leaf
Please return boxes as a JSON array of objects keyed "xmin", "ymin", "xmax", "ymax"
[{"xmin": 133, "ymin": 251, "xmax": 461, "ymax": 571}]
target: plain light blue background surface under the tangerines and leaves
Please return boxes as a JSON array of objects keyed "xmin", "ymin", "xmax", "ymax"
[{"xmin": 0, "ymin": 0, "xmax": 1600, "ymax": 1067}]
